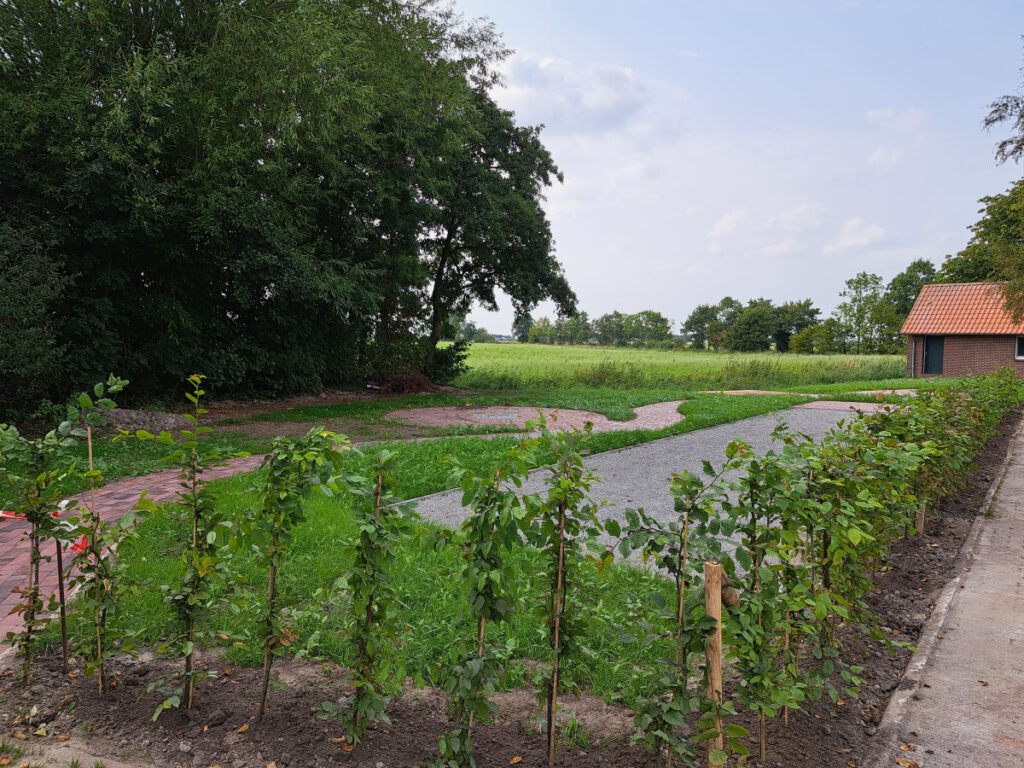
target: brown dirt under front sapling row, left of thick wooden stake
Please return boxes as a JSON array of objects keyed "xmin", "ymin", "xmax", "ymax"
[{"xmin": 0, "ymin": 655, "xmax": 655, "ymax": 768}]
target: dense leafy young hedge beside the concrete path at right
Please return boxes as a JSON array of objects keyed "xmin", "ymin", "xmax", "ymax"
[{"xmin": 702, "ymin": 371, "xmax": 1021, "ymax": 762}]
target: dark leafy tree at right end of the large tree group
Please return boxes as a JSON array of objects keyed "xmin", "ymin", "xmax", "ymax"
[{"xmin": 422, "ymin": 89, "xmax": 575, "ymax": 366}]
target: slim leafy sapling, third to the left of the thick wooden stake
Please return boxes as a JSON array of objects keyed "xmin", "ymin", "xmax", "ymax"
[{"xmin": 437, "ymin": 439, "xmax": 538, "ymax": 768}]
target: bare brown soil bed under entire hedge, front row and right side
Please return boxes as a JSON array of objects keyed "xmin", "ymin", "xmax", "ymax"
[{"xmin": 0, "ymin": 413, "xmax": 1021, "ymax": 768}]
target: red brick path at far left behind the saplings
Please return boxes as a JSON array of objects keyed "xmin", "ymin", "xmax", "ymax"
[{"xmin": 0, "ymin": 456, "xmax": 263, "ymax": 638}]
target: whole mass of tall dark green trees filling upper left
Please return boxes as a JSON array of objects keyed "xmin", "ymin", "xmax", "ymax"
[{"xmin": 0, "ymin": 0, "xmax": 574, "ymax": 415}]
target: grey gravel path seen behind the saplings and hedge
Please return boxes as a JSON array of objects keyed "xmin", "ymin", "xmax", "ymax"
[{"xmin": 416, "ymin": 403, "xmax": 858, "ymax": 526}]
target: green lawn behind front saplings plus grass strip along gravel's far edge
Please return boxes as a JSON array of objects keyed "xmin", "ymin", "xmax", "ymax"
[{"xmin": 54, "ymin": 394, "xmax": 807, "ymax": 702}]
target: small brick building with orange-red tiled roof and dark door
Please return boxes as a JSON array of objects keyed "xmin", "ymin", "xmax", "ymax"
[{"xmin": 901, "ymin": 283, "xmax": 1024, "ymax": 376}]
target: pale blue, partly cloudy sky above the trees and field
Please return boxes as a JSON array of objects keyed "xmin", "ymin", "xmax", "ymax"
[{"xmin": 455, "ymin": 0, "xmax": 1024, "ymax": 333}]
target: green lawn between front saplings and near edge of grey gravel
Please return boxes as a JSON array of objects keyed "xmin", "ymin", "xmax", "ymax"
[{"xmin": 74, "ymin": 468, "xmax": 671, "ymax": 702}]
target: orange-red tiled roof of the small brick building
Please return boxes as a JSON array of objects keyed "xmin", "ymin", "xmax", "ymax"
[{"xmin": 900, "ymin": 283, "xmax": 1024, "ymax": 336}]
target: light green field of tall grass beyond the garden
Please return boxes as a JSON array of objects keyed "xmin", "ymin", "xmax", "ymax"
[{"xmin": 456, "ymin": 344, "xmax": 905, "ymax": 389}]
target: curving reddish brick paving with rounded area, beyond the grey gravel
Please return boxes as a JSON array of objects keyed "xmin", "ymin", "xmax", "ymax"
[{"xmin": 388, "ymin": 400, "xmax": 686, "ymax": 432}]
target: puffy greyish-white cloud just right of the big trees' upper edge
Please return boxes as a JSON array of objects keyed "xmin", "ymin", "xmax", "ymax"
[{"xmin": 499, "ymin": 53, "xmax": 651, "ymax": 133}]
